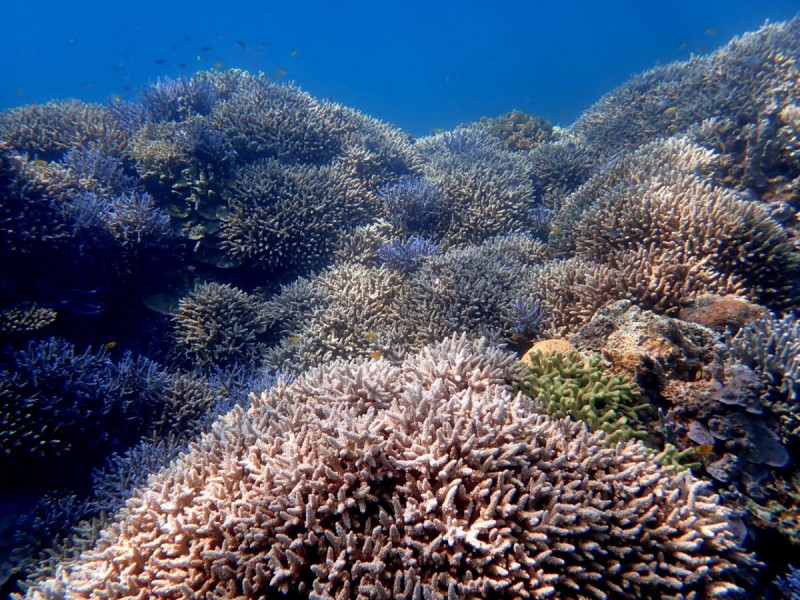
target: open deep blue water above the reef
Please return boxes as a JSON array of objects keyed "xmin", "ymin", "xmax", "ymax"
[{"xmin": 6, "ymin": 0, "xmax": 800, "ymax": 135}]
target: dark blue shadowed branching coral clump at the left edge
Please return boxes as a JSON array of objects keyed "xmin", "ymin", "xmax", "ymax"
[{"xmin": 0, "ymin": 338, "xmax": 177, "ymax": 487}]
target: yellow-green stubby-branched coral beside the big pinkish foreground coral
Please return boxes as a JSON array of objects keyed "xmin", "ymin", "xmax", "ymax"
[{"xmin": 518, "ymin": 350, "xmax": 650, "ymax": 446}]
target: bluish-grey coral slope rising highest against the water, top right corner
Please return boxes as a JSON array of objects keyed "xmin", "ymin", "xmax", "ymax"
[{"xmin": 570, "ymin": 18, "xmax": 800, "ymax": 163}]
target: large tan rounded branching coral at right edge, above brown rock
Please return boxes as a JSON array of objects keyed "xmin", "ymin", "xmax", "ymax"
[{"xmin": 551, "ymin": 137, "xmax": 800, "ymax": 313}]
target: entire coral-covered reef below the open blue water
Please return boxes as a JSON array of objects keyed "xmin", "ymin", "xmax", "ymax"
[{"xmin": 0, "ymin": 19, "xmax": 800, "ymax": 600}]
